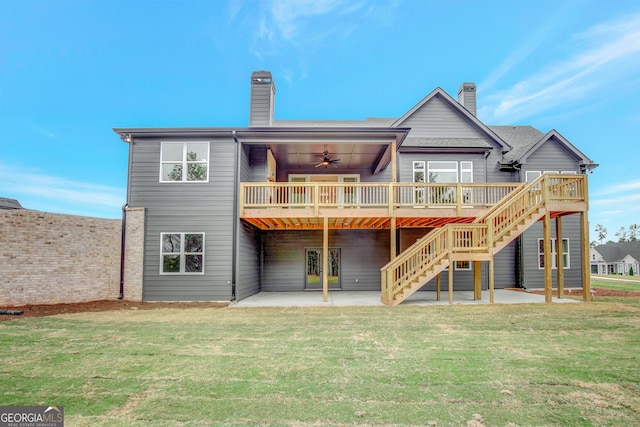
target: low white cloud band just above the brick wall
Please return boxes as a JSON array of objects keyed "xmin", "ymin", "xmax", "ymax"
[{"xmin": 0, "ymin": 164, "xmax": 125, "ymax": 217}]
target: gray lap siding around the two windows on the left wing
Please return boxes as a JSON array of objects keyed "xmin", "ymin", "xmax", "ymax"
[{"xmin": 129, "ymin": 139, "xmax": 236, "ymax": 301}]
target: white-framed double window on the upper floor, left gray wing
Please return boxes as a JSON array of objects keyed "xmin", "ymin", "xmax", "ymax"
[{"xmin": 160, "ymin": 142, "xmax": 209, "ymax": 182}]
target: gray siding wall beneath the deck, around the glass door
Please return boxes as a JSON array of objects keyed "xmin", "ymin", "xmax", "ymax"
[{"xmin": 262, "ymin": 230, "xmax": 389, "ymax": 291}]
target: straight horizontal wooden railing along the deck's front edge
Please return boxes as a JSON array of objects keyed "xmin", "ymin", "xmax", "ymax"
[{"xmin": 240, "ymin": 182, "xmax": 521, "ymax": 213}]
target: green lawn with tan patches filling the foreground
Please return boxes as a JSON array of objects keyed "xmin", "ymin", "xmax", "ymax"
[{"xmin": 0, "ymin": 298, "xmax": 640, "ymax": 427}]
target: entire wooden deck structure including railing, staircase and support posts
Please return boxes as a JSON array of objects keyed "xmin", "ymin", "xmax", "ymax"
[{"xmin": 239, "ymin": 174, "xmax": 590, "ymax": 305}]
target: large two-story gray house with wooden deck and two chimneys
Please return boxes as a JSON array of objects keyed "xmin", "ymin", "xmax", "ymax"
[{"xmin": 114, "ymin": 71, "xmax": 597, "ymax": 305}]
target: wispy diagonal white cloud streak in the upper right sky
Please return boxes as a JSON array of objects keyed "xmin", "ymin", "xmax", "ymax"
[{"xmin": 479, "ymin": 14, "xmax": 640, "ymax": 122}]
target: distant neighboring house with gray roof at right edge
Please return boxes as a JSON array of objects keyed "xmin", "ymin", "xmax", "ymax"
[{"xmin": 589, "ymin": 241, "xmax": 640, "ymax": 276}]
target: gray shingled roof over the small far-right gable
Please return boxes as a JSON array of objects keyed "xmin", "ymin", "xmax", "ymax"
[{"xmin": 496, "ymin": 126, "xmax": 598, "ymax": 170}]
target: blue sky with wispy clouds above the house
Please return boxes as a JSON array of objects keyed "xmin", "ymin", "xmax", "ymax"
[{"xmin": 0, "ymin": 0, "xmax": 640, "ymax": 240}]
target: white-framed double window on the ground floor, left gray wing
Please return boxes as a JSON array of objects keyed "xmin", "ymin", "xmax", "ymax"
[{"xmin": 160, "ymin": 233, "xmax": 204, "ymax": 274}]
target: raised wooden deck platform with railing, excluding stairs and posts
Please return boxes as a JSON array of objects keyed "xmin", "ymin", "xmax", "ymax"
[{"xmin": 240, "ymin": 182, "xmax": 523, "ymax": 230}]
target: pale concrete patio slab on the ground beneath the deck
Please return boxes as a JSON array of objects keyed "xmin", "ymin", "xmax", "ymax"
[{"xmin": 229, "ymin": 289, "xmax": 581, "ymax": 308}]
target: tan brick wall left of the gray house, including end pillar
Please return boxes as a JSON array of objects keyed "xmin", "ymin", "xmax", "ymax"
[{"xmin": 0, "ymin": 209, "xmax": 144, "ymax": 306}]
